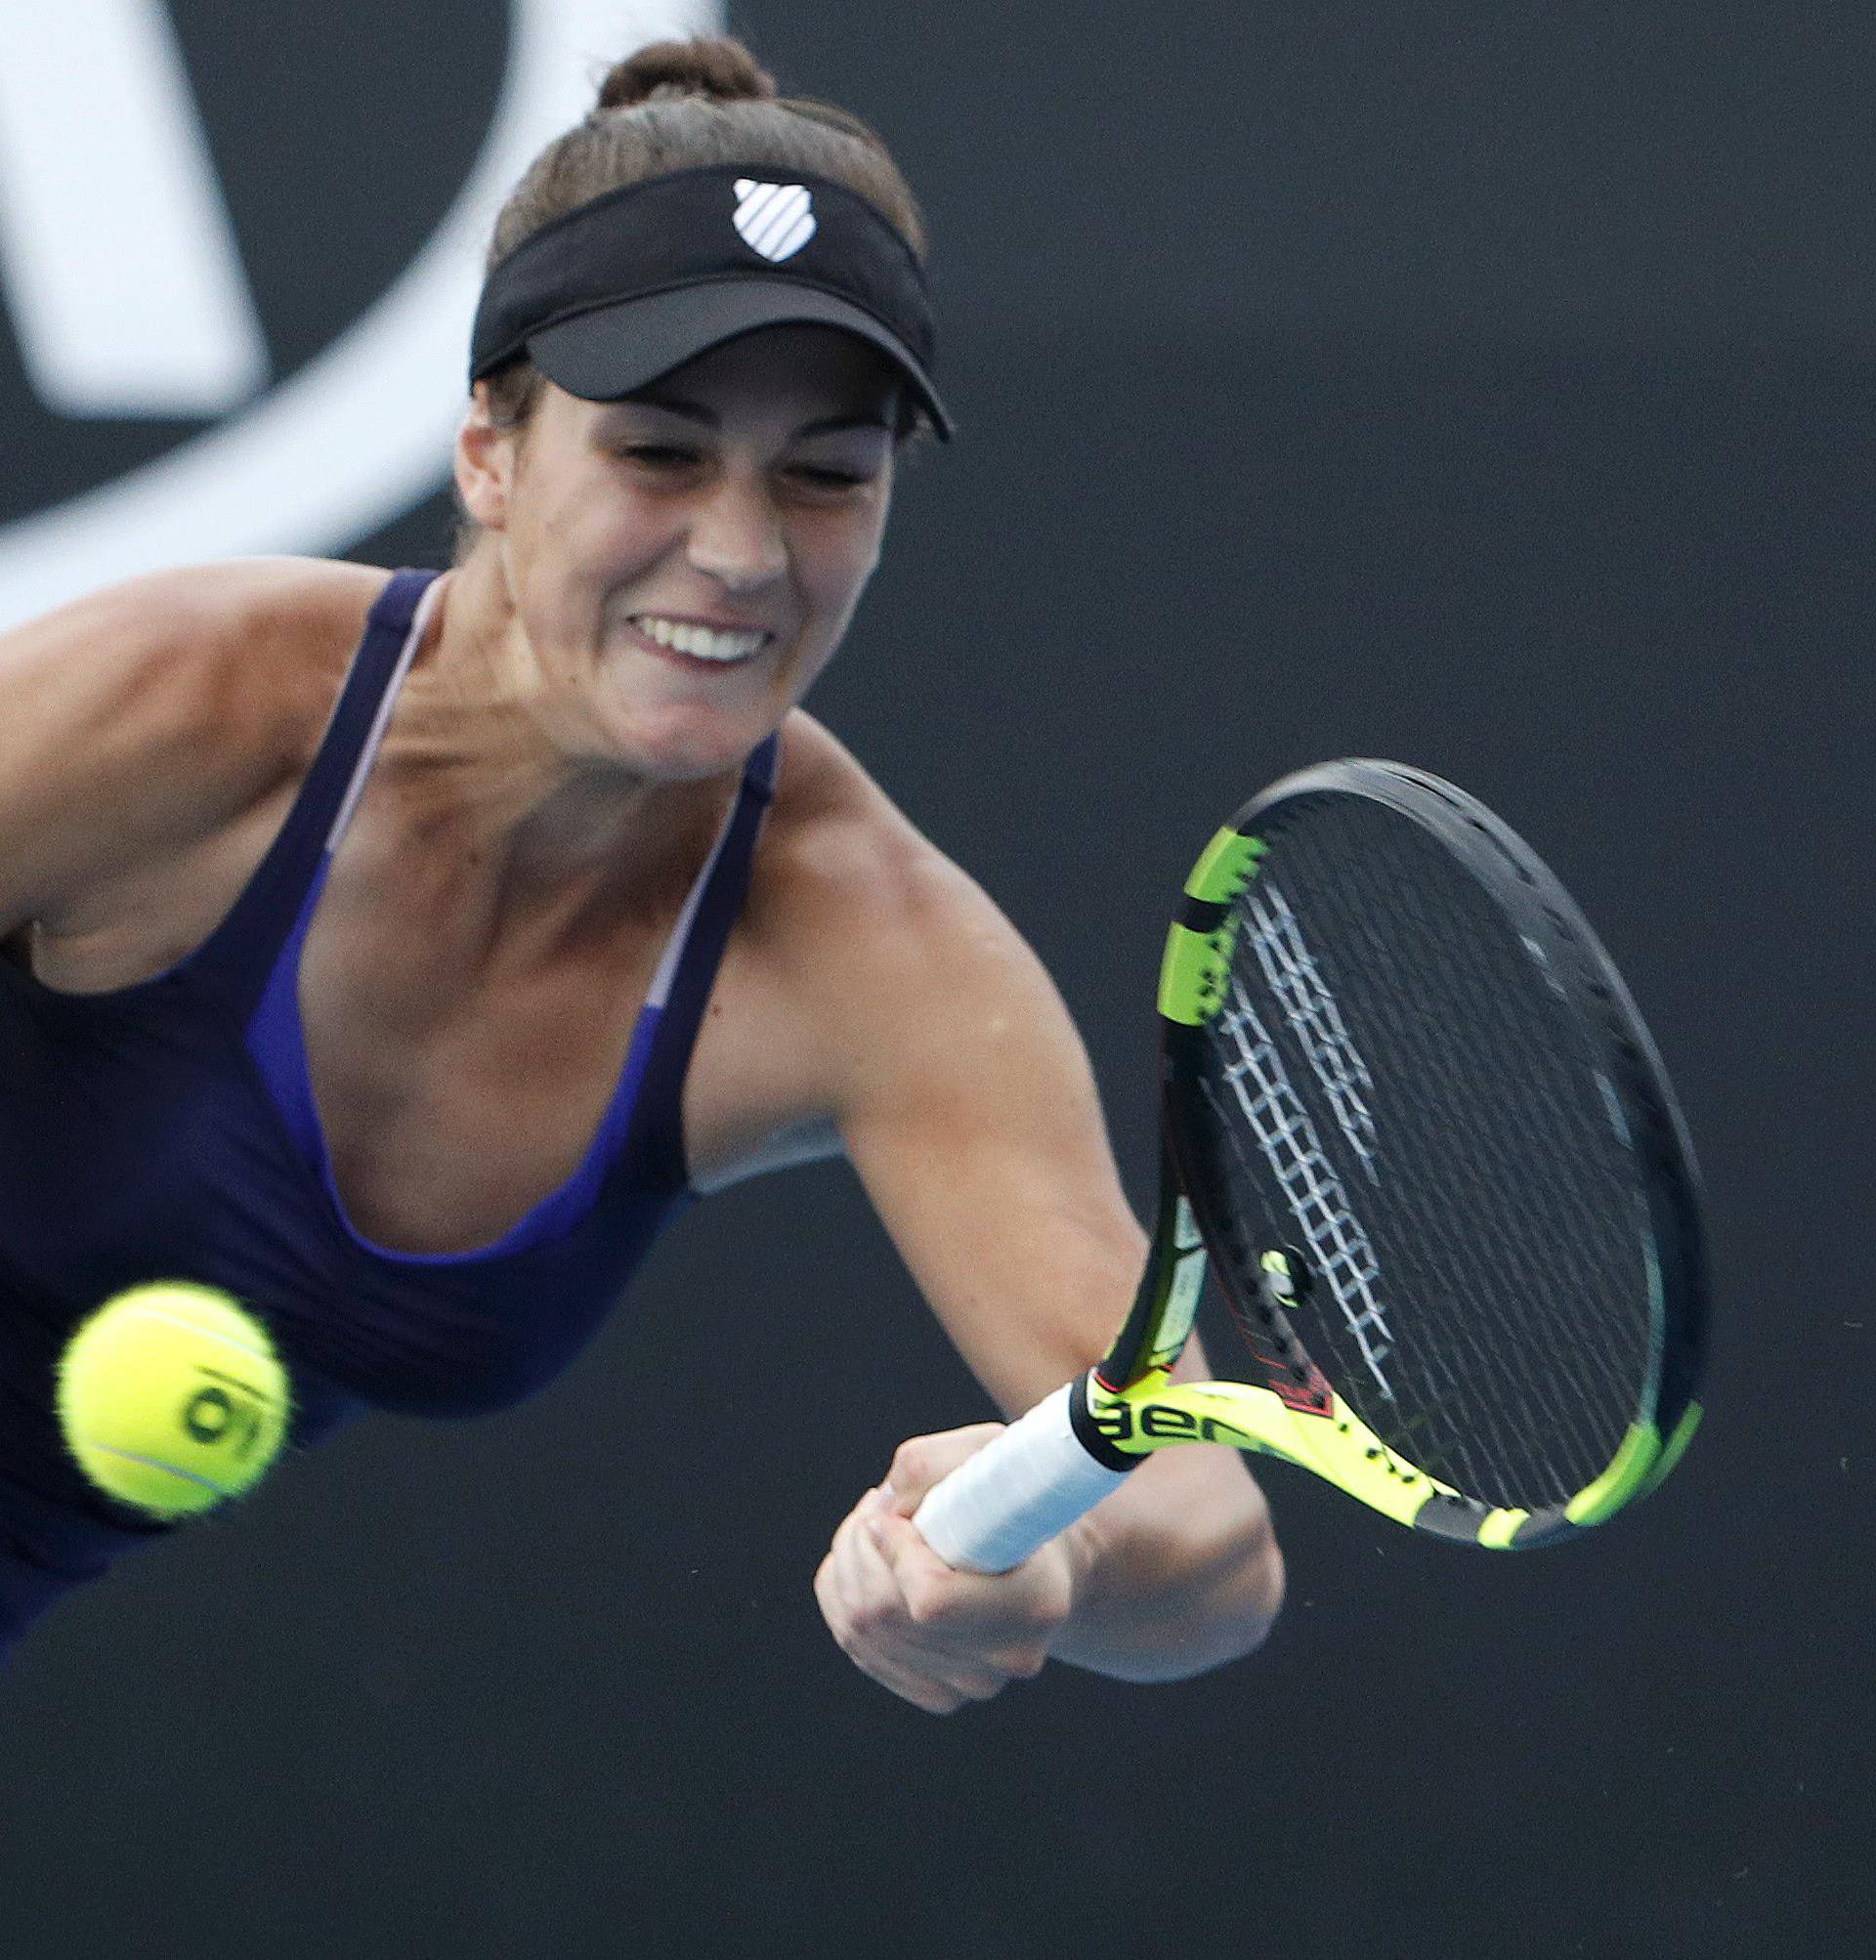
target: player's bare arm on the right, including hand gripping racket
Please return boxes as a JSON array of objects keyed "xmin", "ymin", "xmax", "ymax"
[{"xmin": 784, "ymin": 803, "xmax": 1282, "ymax": 1709}]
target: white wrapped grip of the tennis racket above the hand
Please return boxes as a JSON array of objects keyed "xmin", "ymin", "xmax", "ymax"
[{"xmin": 912, "ymin": 1382, "xmax": 1128, "ymax": 1572}]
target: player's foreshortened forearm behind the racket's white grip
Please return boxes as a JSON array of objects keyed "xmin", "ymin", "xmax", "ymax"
[{"xmin": 1048, "ymin": 1450, "xmax": 1284, "ymax": 1682}]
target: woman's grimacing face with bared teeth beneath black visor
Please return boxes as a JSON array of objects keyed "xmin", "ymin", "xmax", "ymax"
[{"xmin": 464, "ymin": 325, "xmax": 898, "ymax": 780}]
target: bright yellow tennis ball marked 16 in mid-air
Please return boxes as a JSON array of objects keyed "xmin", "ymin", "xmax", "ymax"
[{"xmin": 57, "ymin": 1280, "xmax": 290, "ymax": 1519}]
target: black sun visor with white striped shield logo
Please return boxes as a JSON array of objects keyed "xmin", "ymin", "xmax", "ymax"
[{"xmin": 468, "ymin": 162, "xmax": 951, "ymax": 439}]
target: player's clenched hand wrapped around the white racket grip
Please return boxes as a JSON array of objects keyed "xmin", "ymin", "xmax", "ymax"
[{"xmin": 814, "ymin": 1423, "xmax": 1074, "ymax": 1715}]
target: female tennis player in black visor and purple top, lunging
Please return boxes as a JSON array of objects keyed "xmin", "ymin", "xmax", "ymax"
[{"xmin": 0, "ymin": 39, "xmax": 1282, "ymax": 1711}]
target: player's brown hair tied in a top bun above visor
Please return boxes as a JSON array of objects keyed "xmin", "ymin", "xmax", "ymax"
[{"xmin": 489, "ymin": 35, "xmax": 925, "ymax": 427}]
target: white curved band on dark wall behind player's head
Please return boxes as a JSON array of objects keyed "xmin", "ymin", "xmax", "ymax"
[{"xmin": 0, "ymin": 0, "xmax": 719, "ymax": 629}]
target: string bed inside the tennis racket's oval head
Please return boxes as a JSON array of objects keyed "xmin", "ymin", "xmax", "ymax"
[{"xmin": 1204, "ymin": 797, "xmax": 1652, "ymax": 1510}]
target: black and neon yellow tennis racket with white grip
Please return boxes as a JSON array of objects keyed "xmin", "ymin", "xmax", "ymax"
[{"xmin": 914, "ymin": 760, "xmax": 1707, "ymax": 1572}]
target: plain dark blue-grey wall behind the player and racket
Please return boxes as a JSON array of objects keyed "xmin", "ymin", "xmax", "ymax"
[{"xmin": 0, "ymin": 0, "xmax": 1876, "ymax": 1960}]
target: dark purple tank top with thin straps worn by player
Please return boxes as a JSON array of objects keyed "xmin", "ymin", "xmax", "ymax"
[{"xmin": 0, "ymin": 573, "xmax": 778, "ymax": 1652}]
